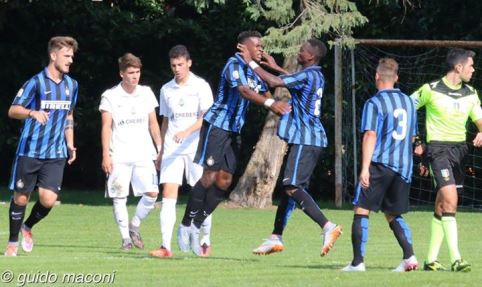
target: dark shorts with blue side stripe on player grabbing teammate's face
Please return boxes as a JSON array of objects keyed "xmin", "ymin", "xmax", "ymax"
[{"xmin": 283, "ymin": 144, "xmax": 323, "ymax": 189}]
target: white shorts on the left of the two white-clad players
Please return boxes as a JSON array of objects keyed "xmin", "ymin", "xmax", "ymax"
[{"xmin": 105, "ymin": 161, "xmax": 159, "ymax": 198}]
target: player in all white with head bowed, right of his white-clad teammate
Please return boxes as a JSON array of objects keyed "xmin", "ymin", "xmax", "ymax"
[{"xmin": 149, "ymin": 45, "xmax": 213, "ymax": 257}]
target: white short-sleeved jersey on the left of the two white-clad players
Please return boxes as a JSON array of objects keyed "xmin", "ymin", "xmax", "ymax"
[{"xmin": 99, "ymin": 84, "xmax": 158, "ymax": 162}]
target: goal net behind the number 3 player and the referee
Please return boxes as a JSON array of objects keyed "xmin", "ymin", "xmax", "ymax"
[{"xmin": 342, "ymin": 42, "xmax": 482, "ymax": 209}]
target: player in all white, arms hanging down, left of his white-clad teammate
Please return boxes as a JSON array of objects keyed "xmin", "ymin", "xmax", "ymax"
[{"xmin": 99, "ymin": 53, "xmax": 161, "ymax": 250}]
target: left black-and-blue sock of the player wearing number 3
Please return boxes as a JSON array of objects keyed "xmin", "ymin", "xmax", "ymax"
[{"xmin": 351, "ymin": 214, "xmax": 368, "ymax": 266}]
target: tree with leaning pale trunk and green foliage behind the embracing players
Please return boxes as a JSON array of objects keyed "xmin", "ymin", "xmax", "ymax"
[{"xmin": 230, "ymin": 0, "xmax": 368, "ymax": 208}]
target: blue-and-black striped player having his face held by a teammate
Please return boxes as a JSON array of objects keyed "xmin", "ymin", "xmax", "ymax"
[{"xmin": 178, "ymin": 31, "xmax": 291, "ymax": 255}]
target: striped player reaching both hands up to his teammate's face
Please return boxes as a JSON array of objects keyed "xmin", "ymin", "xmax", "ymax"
[{"xmin": 238, "ymin": 39, "xmax": 342, "ymax": 256}]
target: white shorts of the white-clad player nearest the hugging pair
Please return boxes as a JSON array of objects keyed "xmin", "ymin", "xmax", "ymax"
[{"xmin": 160, "ymin": 155, "xmax": 203, "ymax": 186}]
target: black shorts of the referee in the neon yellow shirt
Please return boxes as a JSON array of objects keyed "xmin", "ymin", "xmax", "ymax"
[{"xmin": 427, "ymin": 142, "xmax": 468, "ymax": 189}]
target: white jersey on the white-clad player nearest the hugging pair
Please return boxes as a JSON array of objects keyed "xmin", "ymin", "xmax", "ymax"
[{"xmin": 159, "ymin": 72, "xmax": 213, "ymax": 157}]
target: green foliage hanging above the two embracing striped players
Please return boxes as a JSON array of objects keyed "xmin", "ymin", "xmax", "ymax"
[{"xmin": 244, "ymin": 0, "xmax": 368, "ymax": 56}]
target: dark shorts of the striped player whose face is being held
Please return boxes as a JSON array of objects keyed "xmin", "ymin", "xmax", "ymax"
[{"xmin": 194, "ymin": 121, "xmax": 241, "ymax": 174}]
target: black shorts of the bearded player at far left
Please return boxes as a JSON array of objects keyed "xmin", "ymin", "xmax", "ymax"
[{"xmin": 9, "ymin": 156, "xmax": 66, "ymax": 193}]
